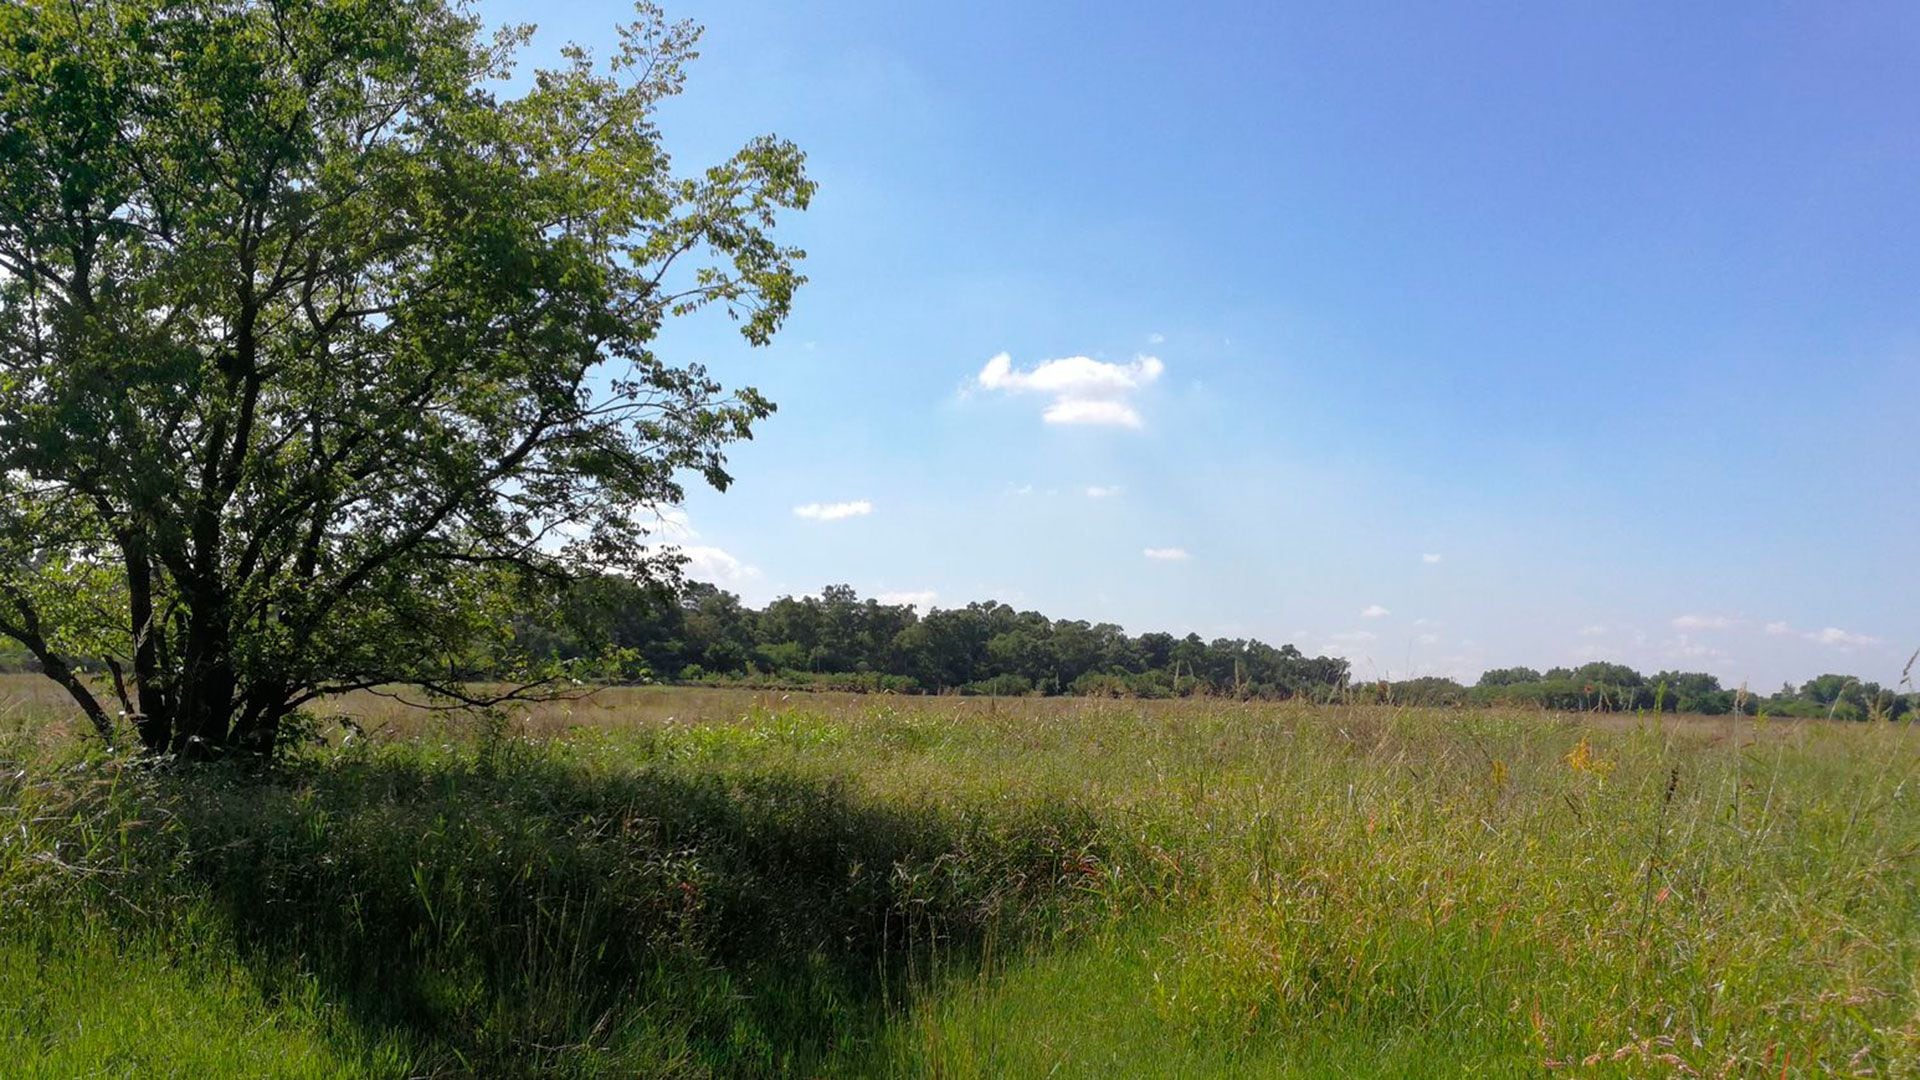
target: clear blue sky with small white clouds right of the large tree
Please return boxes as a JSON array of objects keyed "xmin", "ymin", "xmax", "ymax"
[{"xmin": 482, "ymin": 2, "xmax": 1920, "ymax": 690}]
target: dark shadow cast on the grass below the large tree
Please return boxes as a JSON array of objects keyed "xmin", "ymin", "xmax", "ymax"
[{"xmin": 169, "ymin": 744, "xmax": 1096, "ymax": 1076}]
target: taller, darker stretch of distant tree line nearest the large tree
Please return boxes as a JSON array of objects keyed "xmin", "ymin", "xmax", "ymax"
[{"xmin": 516, "ymin": 577, "xmax": 1350, "ymax": 701}]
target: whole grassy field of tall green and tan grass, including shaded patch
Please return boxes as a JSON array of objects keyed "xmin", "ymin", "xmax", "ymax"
[{"xmin": 0, "ymin": 682, "xmax": 1920, "ymax": 1078}]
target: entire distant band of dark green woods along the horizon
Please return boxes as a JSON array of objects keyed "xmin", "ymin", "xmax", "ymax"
[{"xmin": 516, "ymin": 578, "xmax": 1920, "ymax": 721}]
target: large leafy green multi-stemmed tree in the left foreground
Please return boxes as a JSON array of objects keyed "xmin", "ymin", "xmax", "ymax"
[{"xmin": 0, "ymin": 0, "xmax": 812, "ymax": 753}]
